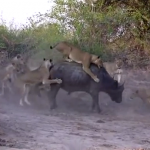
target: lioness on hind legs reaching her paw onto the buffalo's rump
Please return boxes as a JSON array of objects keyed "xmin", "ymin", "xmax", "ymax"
[{"xmin": 15, "ymin": 58, "xmax": 62, "ymax": 106}]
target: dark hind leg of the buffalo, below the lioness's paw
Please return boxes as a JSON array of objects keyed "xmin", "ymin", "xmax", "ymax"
[{"xmin": 47, "ymin": 85, "xmax": 60, "ymax": 110}]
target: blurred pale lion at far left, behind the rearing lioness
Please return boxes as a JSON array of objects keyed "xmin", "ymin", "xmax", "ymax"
[{"xmin": 0, "ymin": 54, "xmax": 24, "ymax": 96}]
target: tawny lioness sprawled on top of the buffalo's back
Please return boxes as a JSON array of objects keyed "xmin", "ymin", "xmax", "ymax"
[{"xmin": 50, "ymin": 41, "xmax": 103, "ymax": 82}]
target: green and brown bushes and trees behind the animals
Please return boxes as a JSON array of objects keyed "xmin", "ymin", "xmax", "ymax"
[{"xmin": 0, "ymin": 0, "xmax": 150, "ymax": 67}]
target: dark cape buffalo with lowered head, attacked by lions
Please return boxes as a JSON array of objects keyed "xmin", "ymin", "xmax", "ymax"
[{"xmin": 48, "ymin": 62, "xmax": 124, "ymax": 113}]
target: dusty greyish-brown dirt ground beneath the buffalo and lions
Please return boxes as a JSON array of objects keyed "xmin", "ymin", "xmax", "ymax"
[{"xmin": 0, "ymin": 69, "xmax": 150, "ymax": 150}]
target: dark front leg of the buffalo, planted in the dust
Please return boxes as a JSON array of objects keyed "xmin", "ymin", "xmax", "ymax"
[{"xmin": 91, "ymin": 93, "xmax": 101, "ymax": 113}]
